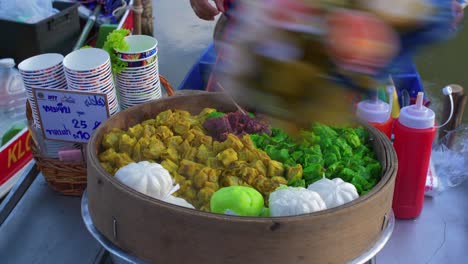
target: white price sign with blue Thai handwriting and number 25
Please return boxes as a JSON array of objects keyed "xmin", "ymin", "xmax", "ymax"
[{"xmin": 33, "ymin": 88, "xmax": 109, "ymax": 143}]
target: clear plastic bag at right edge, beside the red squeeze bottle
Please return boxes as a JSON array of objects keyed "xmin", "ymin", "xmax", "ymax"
[{"xmin": 425, "ymin": 125, "xmax": 468, "ymax": 196}]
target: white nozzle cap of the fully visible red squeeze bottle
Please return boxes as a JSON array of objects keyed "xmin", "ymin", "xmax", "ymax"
[{"xmin": 398, "ymin": 92, "xmax": 435, "ymax": 129}]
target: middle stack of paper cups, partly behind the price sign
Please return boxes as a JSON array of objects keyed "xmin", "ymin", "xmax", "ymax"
[{"xmin": 63, "ymin": 48, "xmax": 120, "ymax": 115}]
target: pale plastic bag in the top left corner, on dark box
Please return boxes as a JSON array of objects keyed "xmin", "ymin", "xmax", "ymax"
[{"xmin": 0, "ymin": 0, "xmax": 58, "ymax": 24}]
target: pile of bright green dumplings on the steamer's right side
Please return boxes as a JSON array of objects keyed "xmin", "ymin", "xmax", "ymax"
[{"xmin": 250, "ymin": 124, "xmax": 382, "ymax": 195}]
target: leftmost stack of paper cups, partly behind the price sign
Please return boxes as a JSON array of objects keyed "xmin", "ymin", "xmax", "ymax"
[{"xmin": 18, "ymin": 53, "xmax": 67, "ymax": 128}]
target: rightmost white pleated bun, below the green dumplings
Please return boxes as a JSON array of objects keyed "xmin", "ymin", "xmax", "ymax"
[{"xmin": 307, "ymin": 178, "xmax": 359, "ymax": 208}]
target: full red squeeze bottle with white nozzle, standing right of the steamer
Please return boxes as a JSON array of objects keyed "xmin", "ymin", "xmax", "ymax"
[{"xmin": 393, "ymin": 92, "xmax": 436, "ymax": 219}]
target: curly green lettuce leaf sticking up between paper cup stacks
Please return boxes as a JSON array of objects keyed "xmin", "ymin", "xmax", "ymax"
[{"xmin": 102, "ymin": 29, "xmax": 130, "ymax": 73}]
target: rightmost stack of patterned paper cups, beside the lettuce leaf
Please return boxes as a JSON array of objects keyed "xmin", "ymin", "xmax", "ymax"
[{"xmin": 116, "ymin": 35, "xmax": 161, "ymax": 109}]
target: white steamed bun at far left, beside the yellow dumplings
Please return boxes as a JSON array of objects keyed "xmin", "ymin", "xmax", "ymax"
[{"xmin": 115, "ymin": 161, "xmax": 179, "ymax": 200}]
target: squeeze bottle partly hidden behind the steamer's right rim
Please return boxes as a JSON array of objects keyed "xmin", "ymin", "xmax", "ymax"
[{"xmin": 356, "ymin": 98, "xmax": 393, "ymax": 138}]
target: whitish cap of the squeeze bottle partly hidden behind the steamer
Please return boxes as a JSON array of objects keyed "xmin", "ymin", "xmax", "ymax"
[{"xmin": 356, "ymin": 99, "xmax": 391, "ymax": 123}]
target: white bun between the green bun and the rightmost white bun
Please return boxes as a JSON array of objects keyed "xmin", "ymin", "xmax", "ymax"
[{"xmin": 269, "ymin": 187, "xmax": 327, "ymax": 216}]
